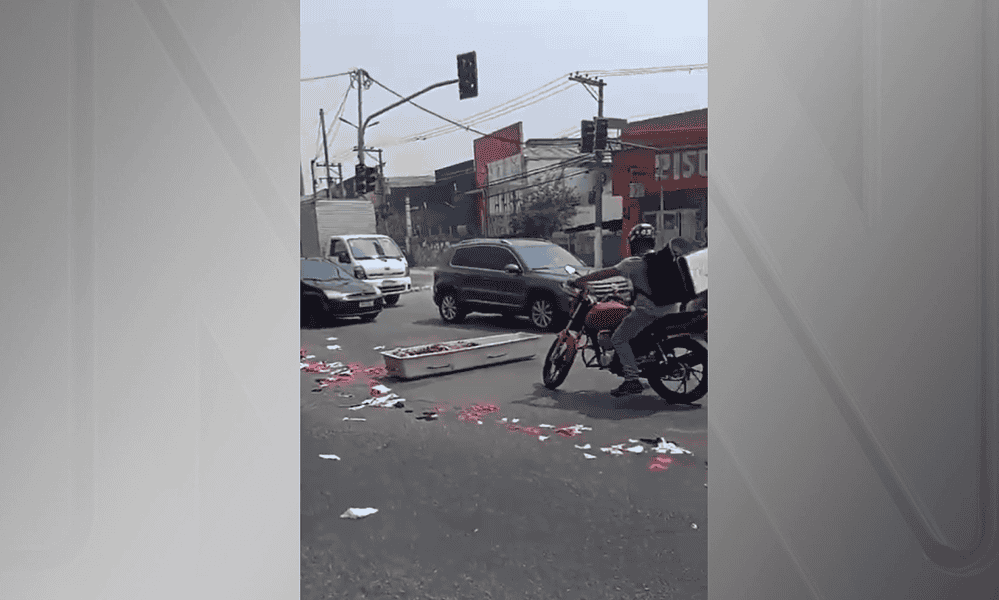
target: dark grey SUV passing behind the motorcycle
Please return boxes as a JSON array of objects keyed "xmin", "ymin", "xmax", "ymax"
[{"xmin": 434, "ymin": 238, "xmax": 631, "ymax": 331}]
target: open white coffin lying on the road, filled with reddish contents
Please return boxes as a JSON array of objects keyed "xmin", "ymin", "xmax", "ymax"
[{"xmin": 381, "ymin": 332, "xmax": 541, "ymax": 379}]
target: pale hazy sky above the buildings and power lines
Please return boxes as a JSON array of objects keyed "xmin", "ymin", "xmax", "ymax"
[{"xmin": 300, "ymin": 0, "xmax": 708, "ymax": 185}]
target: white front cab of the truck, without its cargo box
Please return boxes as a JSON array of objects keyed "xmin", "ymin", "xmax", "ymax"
[{"xmin": 327, "ymin": 233, "xmax": 413, "ymax": 306}]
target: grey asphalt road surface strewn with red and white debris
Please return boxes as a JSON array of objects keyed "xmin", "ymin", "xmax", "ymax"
[{"xmin": 301, "ymin": 272, "xmax": 709, "ymax": 600}]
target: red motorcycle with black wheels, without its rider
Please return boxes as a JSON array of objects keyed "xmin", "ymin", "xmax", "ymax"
[{"xmin": 542, "ymin": 270, "xmax": 708, "ymax": 404}]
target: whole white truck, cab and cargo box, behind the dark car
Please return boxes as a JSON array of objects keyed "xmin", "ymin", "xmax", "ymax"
[{"xmin": 301, "ymin": 196, "xmax": 413, "ymax": 306}]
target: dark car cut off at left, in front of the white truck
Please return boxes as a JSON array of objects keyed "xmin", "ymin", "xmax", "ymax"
[{"xmin": 302, "ymin": 258, "xmax": 385, "ymax": 326}]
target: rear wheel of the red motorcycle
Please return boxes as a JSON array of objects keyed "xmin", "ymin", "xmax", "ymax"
[{"xmin": 648, "ymin": 336, "xmax": 708, "ymax": 404}]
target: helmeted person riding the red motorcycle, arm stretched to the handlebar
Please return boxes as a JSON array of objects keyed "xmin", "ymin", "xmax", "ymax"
[{"xmin": 569, "ymin": 223, "xmax": 680, "ymax": 397}]
